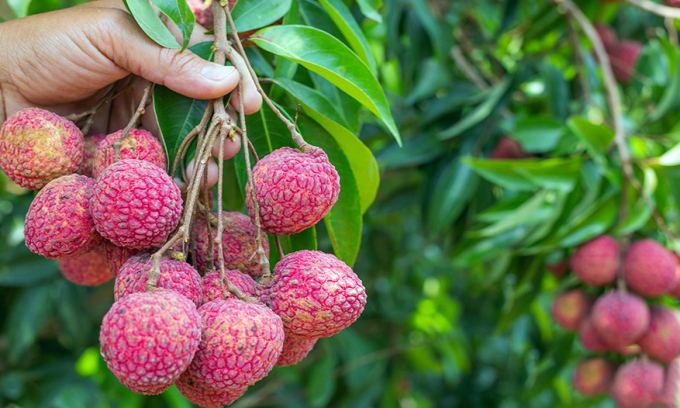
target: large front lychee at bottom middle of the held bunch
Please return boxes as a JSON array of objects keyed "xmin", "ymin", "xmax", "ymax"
[{"xmin": 180, "ymin": 299, "xmax": 284, "ymax": 393}]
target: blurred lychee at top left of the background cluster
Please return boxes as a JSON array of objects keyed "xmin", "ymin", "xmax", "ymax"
[{"xmin": 570, "ymin": 235, "xmax": 621, "ymax": 286}]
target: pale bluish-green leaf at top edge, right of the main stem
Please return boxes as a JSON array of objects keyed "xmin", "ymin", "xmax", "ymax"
[{"xmin": 227, "ymin": 0, "xmax": 292, "ymax": 32}]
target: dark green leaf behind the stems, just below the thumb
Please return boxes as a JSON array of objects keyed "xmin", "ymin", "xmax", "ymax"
[{"xmin": 153, "ymin": 42, "xmax": 212, "ymax": 176}]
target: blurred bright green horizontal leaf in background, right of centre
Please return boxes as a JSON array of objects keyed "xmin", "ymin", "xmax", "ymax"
[{"xmin": 463, "ymin": 157, "xmax": 582, "ymax": 192}]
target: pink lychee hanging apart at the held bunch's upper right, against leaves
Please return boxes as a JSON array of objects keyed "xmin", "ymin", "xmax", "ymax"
[{"xmin": 246, "ymin": 147, "xmax": 340, "ymax": 235}]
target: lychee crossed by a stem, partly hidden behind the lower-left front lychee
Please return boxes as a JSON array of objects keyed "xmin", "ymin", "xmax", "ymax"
[{"xmin": 113, "ymin": 254, "xmax": 203, "ymax": 307}]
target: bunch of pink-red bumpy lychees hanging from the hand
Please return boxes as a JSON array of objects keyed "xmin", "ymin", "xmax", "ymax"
[{"xmin": 0, "ymin": 108, "xmax": 366, "ymax": 408}]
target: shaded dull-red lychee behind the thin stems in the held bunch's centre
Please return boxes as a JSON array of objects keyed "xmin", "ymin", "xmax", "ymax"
[{"xmin": 195, "ymin": 211, "xmax": 269, "ymax": 279}]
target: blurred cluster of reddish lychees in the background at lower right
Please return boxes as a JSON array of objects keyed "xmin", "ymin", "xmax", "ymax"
[{"xmin": 550, "ymin": 235, "xmax": 680, "ymax": 408}]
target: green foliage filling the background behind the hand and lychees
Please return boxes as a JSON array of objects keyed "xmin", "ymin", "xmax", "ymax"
[{"xmin": 0, "ymin": 0, "xmax": 680, "ymax": 408}]
